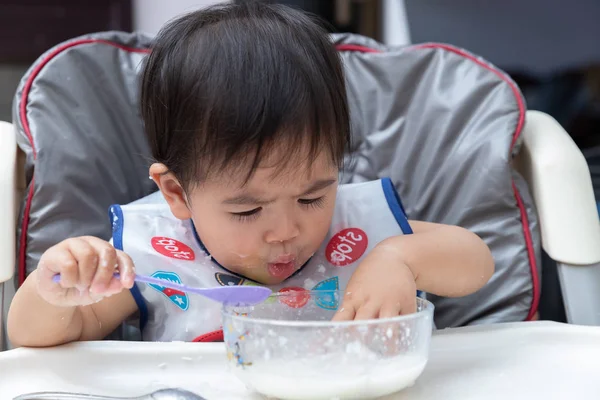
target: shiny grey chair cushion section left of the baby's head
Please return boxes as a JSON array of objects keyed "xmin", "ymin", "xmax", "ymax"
[{"xmin": 13, "ymin": 32, "xmax": 155, "ymax": 279}]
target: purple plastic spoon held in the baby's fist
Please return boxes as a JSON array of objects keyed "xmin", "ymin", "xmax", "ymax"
[{"xmin": 52, "ymin": 273, "xmax": 272, "ymax": 305}]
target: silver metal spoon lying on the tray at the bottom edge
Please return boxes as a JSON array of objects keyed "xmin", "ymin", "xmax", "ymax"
[{"xmin": 13, "ymin": 389, "xmax": 206, "ymax": 400}]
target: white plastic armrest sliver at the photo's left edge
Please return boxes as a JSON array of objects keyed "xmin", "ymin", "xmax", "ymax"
[{"xmin": 0, "ymin": 121, "xmax": 17, "ymax": 283}]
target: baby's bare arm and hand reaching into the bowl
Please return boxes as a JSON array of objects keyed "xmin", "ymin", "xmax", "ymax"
[{"xmin": 335, "ymin": 221, "xmax": 494, "ymax": 320}]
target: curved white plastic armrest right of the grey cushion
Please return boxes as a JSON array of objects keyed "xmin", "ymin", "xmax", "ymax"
[{"xmin": 515, "ymin": 111, "xmax": 600, "ymax": 265}]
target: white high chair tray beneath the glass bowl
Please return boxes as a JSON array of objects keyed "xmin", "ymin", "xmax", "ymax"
[{"xmin": 0, "ymin": 322, "xmax": 600, "ymax": 400}]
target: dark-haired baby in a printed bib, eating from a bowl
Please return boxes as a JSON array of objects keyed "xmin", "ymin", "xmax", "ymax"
[{"xmin": 8, "ymin": 2, "xmax": 494, "ymax": 346}]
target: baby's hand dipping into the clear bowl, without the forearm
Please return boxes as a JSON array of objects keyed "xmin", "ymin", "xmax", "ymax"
[{"xmin": 333, "ymin": 246, "xmax": 417, "ymax": 321}]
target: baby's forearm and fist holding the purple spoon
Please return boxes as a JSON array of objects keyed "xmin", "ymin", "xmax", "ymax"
[{"xmin": 8, "ymin": 237, "xmax": 137, "ymax": 347}]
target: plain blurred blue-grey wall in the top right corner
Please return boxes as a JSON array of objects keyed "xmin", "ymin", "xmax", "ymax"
[{"xmin": 406, "ymin": 0, "xmax": 600, "ymax": 75}]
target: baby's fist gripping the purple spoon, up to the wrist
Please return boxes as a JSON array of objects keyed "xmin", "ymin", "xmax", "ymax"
[{"xmin": 36, "ymin": 236, "xmax": 134, "ymax": 307}]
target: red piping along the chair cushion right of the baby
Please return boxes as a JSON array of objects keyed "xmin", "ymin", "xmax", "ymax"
[{"xmin": 336, "ymin": 43, "xmax": 540, "ymax": 321}]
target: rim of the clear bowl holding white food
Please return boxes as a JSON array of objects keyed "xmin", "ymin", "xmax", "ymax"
[{"xmin": 221, "ymin": 290, "xmax": 435, "ymax": 328}]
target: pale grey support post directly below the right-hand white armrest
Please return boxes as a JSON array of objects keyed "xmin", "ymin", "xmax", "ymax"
[{"xmin": 557, "ymin": 263, "xmax": 600, "ymax": 326}]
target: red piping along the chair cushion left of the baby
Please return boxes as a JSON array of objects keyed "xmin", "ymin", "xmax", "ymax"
[{"xmin": 18, "ymin": 39, "xmax": 150, "ymax": 285}]
